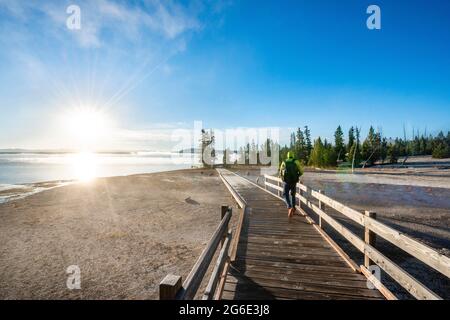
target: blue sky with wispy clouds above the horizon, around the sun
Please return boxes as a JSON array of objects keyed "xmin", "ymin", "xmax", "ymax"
[{"xmin": 0, "ymin": 0, "xmax": 450, "ymax": 149}]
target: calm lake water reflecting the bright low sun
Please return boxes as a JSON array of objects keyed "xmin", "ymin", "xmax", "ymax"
[{"xmin": 0, "ymin": 152, "xmax": 198, "ymax": 184}]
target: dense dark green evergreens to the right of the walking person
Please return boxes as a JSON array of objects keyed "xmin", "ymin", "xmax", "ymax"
[{"xmin": 280, "ymin": 126, "xmax": 450, "ymax": 168}]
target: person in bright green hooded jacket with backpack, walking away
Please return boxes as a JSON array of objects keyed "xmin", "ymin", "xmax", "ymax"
[{"xmin": 280, "ymin": 151, "xmax": 303, "ymax": 218}]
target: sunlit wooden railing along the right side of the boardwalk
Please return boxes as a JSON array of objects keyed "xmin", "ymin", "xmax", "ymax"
[{"xmin": 264, "ymin": 175, "xmax": 450, "ymax": 299}]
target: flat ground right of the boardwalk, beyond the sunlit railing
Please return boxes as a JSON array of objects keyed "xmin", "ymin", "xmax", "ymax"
[{"xmin": 234, "ymin": 162, "xmax": 450, "ymax": 299}]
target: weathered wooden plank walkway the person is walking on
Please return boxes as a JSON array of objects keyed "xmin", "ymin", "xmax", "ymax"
[{"xmin": 221, "ymin": 170, "xmax": 384, "ymax": 300}]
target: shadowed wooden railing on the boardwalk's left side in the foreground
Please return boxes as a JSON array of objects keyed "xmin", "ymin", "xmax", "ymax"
[{"xmin": 159, "ymin": 206, "xmax": 232, "ymax": 300}]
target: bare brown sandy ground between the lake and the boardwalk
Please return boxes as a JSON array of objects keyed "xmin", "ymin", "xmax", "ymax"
[{"xmin": 0, "ymin": 170, "xmax": 234, "ymax": 299}]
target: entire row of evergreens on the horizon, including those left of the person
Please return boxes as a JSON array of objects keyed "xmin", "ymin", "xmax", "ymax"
[{"xmin": 201, "ymin": 125, "xmax": 450, "ymax": 168}]
